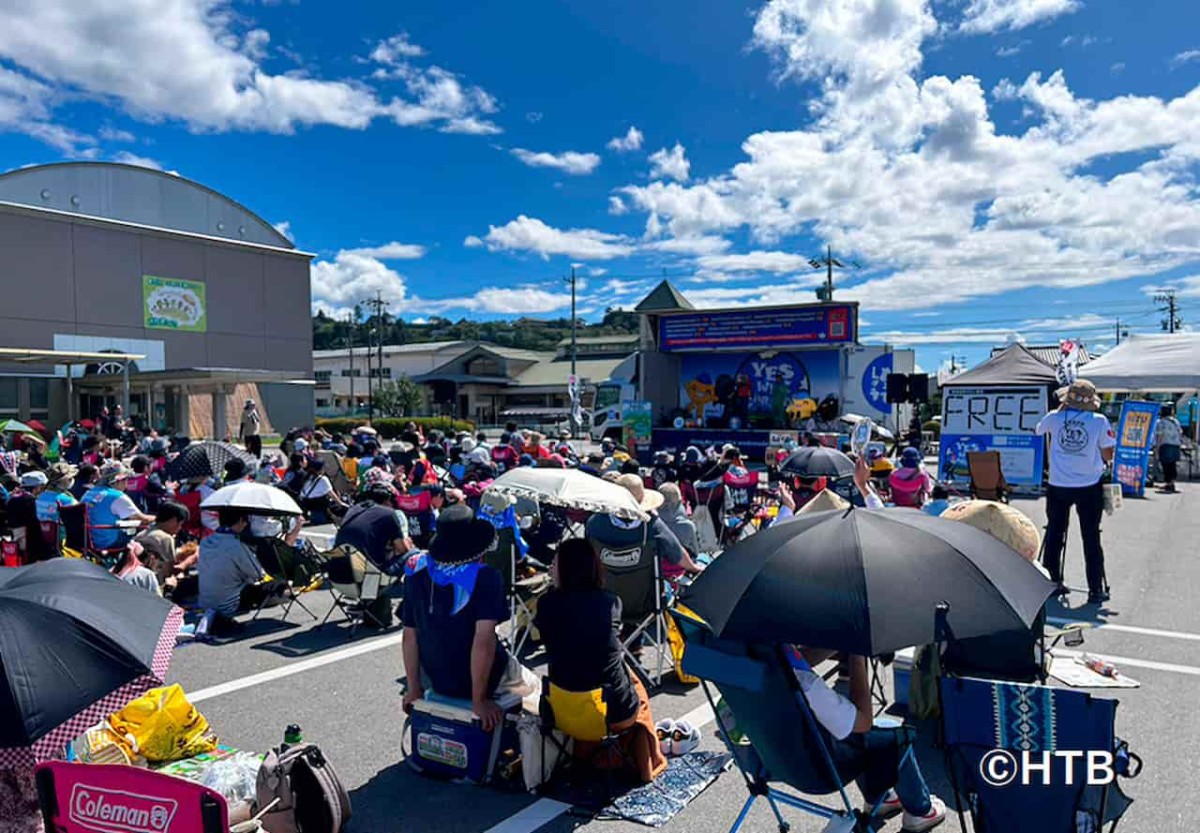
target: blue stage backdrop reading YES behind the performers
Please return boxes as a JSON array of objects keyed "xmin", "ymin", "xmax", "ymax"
[{"xmin": 679, "ymin": 349, "xmax": 841, "ymax": 429}]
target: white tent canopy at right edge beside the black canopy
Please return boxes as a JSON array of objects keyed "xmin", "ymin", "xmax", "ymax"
[{"xmin": 1080, "ymin": 332, "xmax": 1200, "ymax": 392}]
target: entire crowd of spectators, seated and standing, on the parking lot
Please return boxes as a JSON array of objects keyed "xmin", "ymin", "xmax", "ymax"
[{"xmin": 9, "ymin": 389, "xmax": 1128, "ymax": 831}]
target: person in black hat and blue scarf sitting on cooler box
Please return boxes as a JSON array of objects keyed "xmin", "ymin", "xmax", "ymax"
[{"xmin": 402, "ymin": 504, "xmax": 540, "ymax": 731}]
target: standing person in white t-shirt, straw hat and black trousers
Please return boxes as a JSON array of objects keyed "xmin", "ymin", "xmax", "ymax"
[{"xmin": 1037, "ymin": 379, "xmax": 1117, "ymax": 605}]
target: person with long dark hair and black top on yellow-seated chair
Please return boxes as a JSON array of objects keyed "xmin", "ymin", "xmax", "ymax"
[{"xmin": 535, "ymin": 538, "xmax": 666, "ymax": 783}]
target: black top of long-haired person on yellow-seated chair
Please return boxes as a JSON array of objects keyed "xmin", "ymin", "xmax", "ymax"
[{"xmin": 536, "ymin": 589, "xmax": 637, "ymax": 724}]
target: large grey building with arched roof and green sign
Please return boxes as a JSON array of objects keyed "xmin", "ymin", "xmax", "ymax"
[{"xmin": 0, "ymin": 162, "xmax": 313, "ymax": 436}]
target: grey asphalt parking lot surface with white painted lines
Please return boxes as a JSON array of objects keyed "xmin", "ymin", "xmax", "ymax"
[{"xmin": 162, "ymin": 484, "xmax": 1200, "ymax": 833}]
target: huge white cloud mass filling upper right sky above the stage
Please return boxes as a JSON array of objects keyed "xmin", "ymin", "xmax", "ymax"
[{"xmin": 619, "ymin": 0, "xmax": 1200, "ymax": 310}]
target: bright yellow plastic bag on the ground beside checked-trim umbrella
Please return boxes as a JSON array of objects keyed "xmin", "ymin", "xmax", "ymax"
[{"xmin": 108, "ymin": 685, "xmax": 217, "ymax": 762}]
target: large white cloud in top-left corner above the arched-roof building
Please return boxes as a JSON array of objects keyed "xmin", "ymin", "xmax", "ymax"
[{"xmin": 0, "ymin": 0, "xmax": 499, "ymax": 147}]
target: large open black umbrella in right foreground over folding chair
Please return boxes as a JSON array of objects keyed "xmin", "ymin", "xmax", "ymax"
[{"xmin": 680, "ymin": 509, "xmax": 1054, "ymax": 657}]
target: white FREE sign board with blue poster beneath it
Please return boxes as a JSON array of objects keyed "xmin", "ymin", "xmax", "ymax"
[{"xmin": 938, "ymin": 386, "xmax": 1046, "ymax": 487}]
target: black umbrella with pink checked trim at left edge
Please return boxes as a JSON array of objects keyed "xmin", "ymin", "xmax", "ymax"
[{"xmin": 0, "ymin": 558, "xmax": 184, "ymax": 767}]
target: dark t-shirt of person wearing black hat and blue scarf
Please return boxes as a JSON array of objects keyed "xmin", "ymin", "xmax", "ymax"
[{"xmin": 402, "ymin": 567, "xmax": 509, "ymax": 700}]
